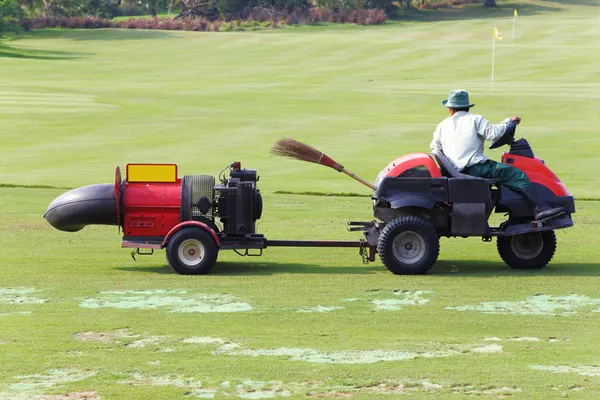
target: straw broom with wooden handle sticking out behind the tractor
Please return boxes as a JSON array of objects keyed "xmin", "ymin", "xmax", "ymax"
[{"xmin": 271, "ymin": 138, "xmax": 377, "ymax": 190}]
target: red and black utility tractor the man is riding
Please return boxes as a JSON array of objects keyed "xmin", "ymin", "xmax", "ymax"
[{"xmin": 373, "ymin": 122, "xmax": 575, "ymax": 274}]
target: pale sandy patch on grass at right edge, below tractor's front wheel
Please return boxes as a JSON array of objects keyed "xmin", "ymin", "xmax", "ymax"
[{"xmin": 446, "ymin": 294, "xmax": 600, "ymax": 316}]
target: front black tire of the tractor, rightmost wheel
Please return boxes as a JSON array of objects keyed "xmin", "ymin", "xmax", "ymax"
[{"xmin": 497, "ymin": 231, "xmax": 556, "ymax": 269}]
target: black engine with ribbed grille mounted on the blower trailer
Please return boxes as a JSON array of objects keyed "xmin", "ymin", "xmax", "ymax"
[{"xmin": 181, "ymin": 162, "xmax": 263, "ymax": 236}]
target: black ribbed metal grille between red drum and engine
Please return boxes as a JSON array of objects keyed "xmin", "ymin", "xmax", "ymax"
[{"xmin": 181, "ymin": 175, "xmax": 215, "ymax": 221}]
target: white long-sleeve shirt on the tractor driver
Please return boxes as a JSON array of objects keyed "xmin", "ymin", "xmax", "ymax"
[{"xmin": 430, "ymin": 111, "xmax": 511, "ymax": 171}]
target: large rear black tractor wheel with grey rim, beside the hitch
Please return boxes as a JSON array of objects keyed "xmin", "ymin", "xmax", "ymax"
[{"xmin": 377, "ymin": 215, "xmax": 440, "ymax": 275}]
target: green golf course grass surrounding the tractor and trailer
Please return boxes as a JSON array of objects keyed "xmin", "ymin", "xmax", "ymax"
[{"xmin": 0, "ymin": 1, "xmax": 600, "ymax": 400}]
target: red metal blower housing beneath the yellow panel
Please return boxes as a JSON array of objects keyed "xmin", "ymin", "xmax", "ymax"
[{"xmin": 123, "ymin": 179, "xmax": 181, "ymax": 237}]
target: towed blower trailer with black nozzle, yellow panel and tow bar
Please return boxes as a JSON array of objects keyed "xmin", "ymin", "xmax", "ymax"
[{"xmin": 44, "ymin": 162, "xmax": 376, "ymax": 274}]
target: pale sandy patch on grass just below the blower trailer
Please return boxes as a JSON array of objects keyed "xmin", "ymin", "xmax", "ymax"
[{"xmin": 79, "ymin": 289, "xmax": 252, "ymax": 313}]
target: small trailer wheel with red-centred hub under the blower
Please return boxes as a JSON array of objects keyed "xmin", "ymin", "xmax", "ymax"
[{"xmin": 167, "ymin": 228, "xmax": 219, "ymax": 275}]
